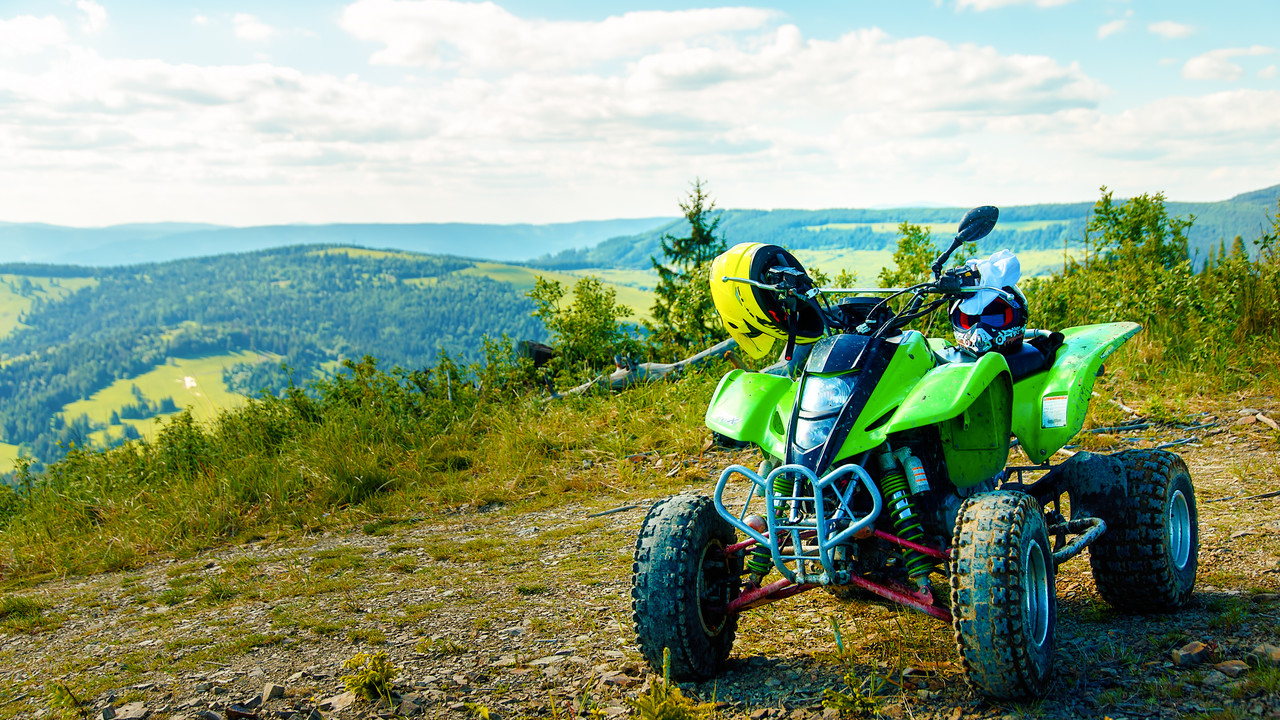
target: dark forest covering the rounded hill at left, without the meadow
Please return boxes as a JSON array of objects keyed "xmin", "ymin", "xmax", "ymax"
[{"xmin": 0, "ymin": 246, "xmax": 543, "ymax": 460}]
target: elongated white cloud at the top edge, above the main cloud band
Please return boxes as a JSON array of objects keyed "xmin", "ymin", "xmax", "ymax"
[{"xmin": 340, "ymin": 0, "xmax": 774, "ymax": 68}]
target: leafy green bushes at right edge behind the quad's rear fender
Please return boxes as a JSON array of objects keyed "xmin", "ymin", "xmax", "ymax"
[{"xmin": 1023, "ymin": 187, "xmax": 1280, "ymax": 389}]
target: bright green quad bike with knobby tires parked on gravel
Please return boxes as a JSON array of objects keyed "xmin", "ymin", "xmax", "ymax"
[{"xmin": 631, "ymin": 206, "xmax": 1199, "ymax": 698}]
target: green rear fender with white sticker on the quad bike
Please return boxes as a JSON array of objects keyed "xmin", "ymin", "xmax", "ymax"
[{"xmin": 1012, "ymin": 323, "xmax": 1142, "ymax": 462}]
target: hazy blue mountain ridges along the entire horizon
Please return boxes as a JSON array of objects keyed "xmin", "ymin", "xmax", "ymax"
[{"xmin": 0, "ymin": 184, "xmax": 1280, "ymax": 269}]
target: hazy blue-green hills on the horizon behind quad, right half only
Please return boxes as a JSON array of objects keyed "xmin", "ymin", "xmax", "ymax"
[{"xmin": 532, "ymin": 186, "xmax": 1280, "ymax": 269}]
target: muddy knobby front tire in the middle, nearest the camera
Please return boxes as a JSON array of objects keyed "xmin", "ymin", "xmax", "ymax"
[{"xmin": 951, "ymin": 491, "xmax": 1057, "ymax": 698}]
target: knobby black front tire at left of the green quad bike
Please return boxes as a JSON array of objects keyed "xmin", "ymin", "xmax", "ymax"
[{"xmin": 631, "ymin": 495, "xmax": 741, "ymax": 680}]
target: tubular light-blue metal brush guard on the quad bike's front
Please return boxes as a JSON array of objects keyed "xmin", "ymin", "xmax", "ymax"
[{"xmin": 714, "ymin": 464, "xmax": 883, "ymax": 585}]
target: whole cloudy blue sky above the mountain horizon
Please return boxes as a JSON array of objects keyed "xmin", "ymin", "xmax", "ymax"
[{"xmin": 0, "ymin": 0, "xmax": 1280, "ymax": 225}]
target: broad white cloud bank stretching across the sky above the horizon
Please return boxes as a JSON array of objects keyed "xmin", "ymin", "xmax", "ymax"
[{"xmin": 0, "ymin": 0, "xmax": 1280, "ymax": 223}]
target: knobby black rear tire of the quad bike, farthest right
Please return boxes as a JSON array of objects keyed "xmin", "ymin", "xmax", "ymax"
[{"xmin": 1089, "ymin": 450, "xmax": 1199, "ymax": 612}]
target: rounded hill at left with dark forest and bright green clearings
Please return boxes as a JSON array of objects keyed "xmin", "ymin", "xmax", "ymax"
[{"xmin": 0, "ymin": 246, "xmax": 650, "ymax": 471}]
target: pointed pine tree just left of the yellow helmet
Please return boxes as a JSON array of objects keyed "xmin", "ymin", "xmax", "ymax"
[{"xmin": 645, "ymin": 178, "xmax": 726, "ymax": 354}]
